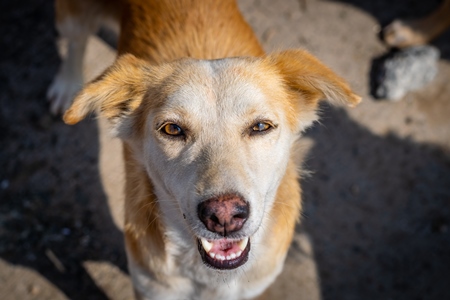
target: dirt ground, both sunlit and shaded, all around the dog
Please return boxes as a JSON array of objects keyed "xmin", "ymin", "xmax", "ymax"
[{"xmin": 0, "ymin": 0, "xmax": 450, "ymax": 300}]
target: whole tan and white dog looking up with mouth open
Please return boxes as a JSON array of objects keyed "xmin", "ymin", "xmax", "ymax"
[{"xmin": 49, "ymin": 0, "xmax": 361, "ymax": 300}]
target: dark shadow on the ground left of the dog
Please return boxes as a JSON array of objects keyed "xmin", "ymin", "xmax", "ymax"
[{"xmin": 0, "ymin": 1, "xmax": 127, "ymax": 299}]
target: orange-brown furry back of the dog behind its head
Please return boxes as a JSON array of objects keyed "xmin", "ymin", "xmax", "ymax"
[{"xmin": 118, "ymin": 0, "xmax": 264, "ymax": 64}]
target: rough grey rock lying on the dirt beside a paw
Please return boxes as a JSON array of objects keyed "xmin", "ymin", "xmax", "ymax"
[{"xmin": 372, "ymin": 46, "xmax": 440, "ymax": 101}]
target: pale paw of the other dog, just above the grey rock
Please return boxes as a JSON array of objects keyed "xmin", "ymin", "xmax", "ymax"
[{"xmin": 383, "ymin": 20, "xmax": 427, "ymax": 48}]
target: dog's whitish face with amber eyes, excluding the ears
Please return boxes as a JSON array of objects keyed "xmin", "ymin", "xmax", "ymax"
[{"xmin": 140, "ymin": 58, "xmax": 297, "ymax": 269}]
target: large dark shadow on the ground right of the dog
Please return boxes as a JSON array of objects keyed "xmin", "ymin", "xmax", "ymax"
[{"xmin": 302, "ymin": 103, "xmax": 450, "ymax": 300}]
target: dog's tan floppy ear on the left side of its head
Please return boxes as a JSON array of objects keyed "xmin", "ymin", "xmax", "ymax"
[{"xmin": 63, "ymin": 54, "xmax": 172, "ymax": 136}]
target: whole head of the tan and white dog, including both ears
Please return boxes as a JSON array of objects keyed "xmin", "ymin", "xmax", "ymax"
[{"xmin": 64, "ymin": 50, "xmax": 360, "ymax": 269}]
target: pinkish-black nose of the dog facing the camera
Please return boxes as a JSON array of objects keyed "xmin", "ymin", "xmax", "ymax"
[{"xmin": 197, "ymin": 195, "xmax": 249, "ymax": 236}]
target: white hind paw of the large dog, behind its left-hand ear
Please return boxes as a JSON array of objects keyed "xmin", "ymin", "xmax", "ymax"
[{"xmin": 47, "ymin": 72, "xmax": 83, "ymax": 115}]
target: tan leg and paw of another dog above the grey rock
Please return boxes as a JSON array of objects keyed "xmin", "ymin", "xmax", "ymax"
[{"xmin": 382, "ymin": 0, "xmax": 450, "ymax": 48}]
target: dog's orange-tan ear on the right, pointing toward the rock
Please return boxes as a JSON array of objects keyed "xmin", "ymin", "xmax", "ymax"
[{"xmin": 266, "ymin": 50, "xmax": 361, "ymax": 130}]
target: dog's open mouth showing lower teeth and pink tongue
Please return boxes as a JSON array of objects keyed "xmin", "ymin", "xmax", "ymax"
[{"xmin": 198, "ymin": 237, "xmax": 250, "ymax": 270}]
